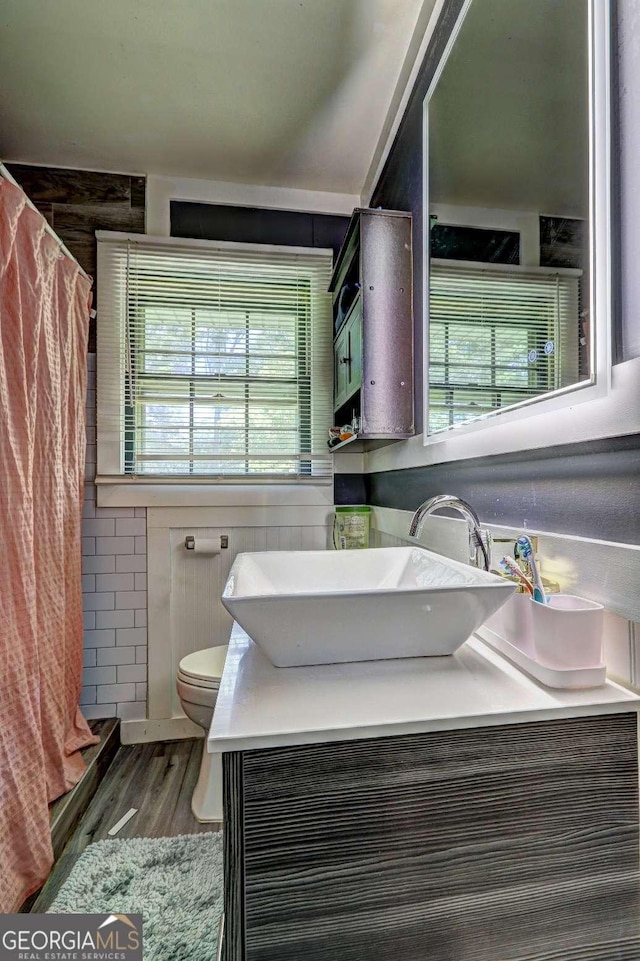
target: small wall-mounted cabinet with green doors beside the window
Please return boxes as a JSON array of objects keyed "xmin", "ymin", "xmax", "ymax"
[{"xmin": 329, "ymin": 208, "xmax": 414, "ymax": 440}]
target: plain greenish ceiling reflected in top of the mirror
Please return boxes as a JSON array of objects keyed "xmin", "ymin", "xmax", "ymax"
[{"xmin": 429, "ymin": 0, "xmax": 589, "ymax": 217}]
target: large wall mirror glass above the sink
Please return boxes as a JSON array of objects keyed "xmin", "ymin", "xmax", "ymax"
[{"xmin": 425, "ymin": 0, "xmax": 593, "ymax": 434}]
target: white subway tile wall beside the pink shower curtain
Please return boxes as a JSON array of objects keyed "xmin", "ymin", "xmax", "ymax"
[{"xmin": 80, "ymin": 354, "xmax": 147, "ymax": 721}]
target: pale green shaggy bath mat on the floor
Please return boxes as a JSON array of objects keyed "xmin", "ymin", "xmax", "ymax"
[{"xmin": 49, "ymin": 832, "xmax": 222, "ymax": 961}]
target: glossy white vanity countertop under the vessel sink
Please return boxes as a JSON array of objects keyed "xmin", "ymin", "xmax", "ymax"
[{"xmin": 208, "ymin": 624, "xmax": 640, "ymax": 752}]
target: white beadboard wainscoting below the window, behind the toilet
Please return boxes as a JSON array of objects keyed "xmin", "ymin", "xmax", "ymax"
[{"xmin": 122, "ymin": 505, "xmax": 333, "ymax": 744}]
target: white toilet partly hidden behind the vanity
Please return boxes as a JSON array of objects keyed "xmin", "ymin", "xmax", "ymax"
[{"xmin": 176, "ymin": 644, "xmax": 227, "ymax": 822}]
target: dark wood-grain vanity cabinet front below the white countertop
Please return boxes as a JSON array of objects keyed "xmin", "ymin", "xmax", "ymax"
[{"xmin": 223, "ymin": 711, "xmax": 640, "ymax": 961}]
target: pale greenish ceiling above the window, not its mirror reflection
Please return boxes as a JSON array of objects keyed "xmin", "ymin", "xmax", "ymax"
[{"xmin": 0, "ymin": 0, "xmax": 435, "ymax": 193}]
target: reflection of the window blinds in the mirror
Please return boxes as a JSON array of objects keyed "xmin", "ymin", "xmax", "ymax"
[{"xmin": 429, "ymin": 260, "xmax": 580, "ymax": 432}]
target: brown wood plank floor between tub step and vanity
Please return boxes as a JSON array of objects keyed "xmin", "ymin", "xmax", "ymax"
[{"xmin": 31, "ymin": 740, "xmax": 222, "ymax": 913}]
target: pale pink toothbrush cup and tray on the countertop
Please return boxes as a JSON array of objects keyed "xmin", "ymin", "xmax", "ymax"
[{"xmin": 477, "ymin": 594, "xmax": 607, "ymax": 690}]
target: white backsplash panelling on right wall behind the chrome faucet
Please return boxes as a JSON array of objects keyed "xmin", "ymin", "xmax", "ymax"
[{"xmin": 371, "ymin": 507, "xmax": 640, "ymax": 689}]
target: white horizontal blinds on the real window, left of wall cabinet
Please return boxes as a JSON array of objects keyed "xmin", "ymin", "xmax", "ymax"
[{"xmin": 97, "ymin": 234, "xmax": 332, "ymax": 479}]
